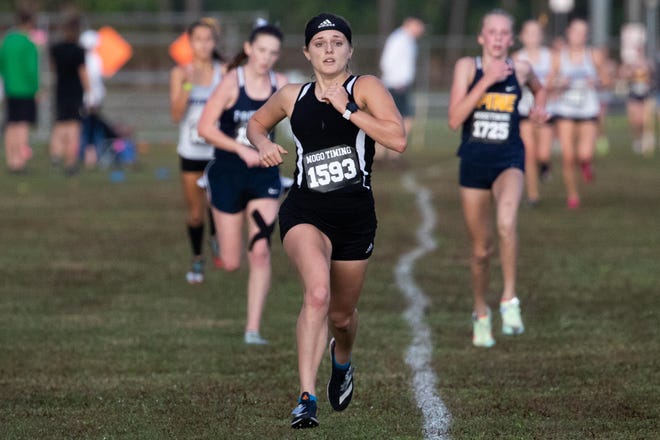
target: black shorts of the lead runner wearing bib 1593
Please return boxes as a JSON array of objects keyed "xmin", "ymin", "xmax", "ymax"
[{"xmin": 279, "ymin": 188, "xmax": 378, "ymax": 261}]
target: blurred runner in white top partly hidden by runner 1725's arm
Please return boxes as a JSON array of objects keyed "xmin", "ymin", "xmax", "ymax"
[{"xmin": 513, "ymin": 20, "xmax": 553, "ymax": 206}]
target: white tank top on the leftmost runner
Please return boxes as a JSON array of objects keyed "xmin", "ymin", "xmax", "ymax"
[{"xmin": 176, "ymin": 63, "xmax": 222, "ymax": 160}]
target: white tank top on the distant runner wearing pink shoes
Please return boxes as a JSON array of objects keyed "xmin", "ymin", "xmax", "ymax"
[{"xmin": 555, "ymin": 49, "xmax": 600, "ymax": 119}]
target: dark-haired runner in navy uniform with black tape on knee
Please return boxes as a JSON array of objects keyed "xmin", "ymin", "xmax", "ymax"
[{"xmin": 198, "ymin": 25, "xmax": 286, "ymax": 345}]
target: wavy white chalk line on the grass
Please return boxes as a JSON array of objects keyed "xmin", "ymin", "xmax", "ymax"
[{"xmin": 395, "ymin": 174, "xmax": 451, "ymax": 440}]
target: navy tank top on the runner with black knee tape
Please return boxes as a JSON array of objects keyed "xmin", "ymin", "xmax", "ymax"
[{"xmin": 214, "ymin": 67, "xmax": 277, "ymax": 163}]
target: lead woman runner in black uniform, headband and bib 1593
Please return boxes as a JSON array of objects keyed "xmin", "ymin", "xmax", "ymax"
[{"xmin": 248, "ymin": 13, "xmax": 406, "ymax": 428}]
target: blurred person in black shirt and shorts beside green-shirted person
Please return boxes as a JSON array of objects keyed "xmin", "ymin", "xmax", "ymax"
[{"xmin": 50, "ymin": 11, "xmax": 89, "ymax": 176}]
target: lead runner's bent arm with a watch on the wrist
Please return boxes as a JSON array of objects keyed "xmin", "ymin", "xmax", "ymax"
[{"xmin": 322, "ymin": 75, "xmax": 407, "ymax": 153}]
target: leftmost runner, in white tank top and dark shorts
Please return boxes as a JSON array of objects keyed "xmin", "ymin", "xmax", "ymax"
[{"xmin": 170, "ymin": 18, "xmax": 224, "ymax": 284}]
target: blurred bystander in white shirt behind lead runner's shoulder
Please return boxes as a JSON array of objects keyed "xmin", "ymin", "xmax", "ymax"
[{"xmin": 375, "ymin": 17, "xmax": 426, "ymax": 160}]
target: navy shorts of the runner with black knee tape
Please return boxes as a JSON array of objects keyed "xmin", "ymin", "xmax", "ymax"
[{"xmin": 205, "ymin": 159, "xmax": 282, "ymax": 214}]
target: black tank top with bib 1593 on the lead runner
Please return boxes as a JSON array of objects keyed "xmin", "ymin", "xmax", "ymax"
[{"xmin": 291, "ymin": 75, "xmax": 374, "ymax": 194}]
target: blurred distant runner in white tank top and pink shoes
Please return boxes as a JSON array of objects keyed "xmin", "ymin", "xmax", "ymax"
[{"xmin": 548, "ymin": 19, "xmax": 609, "ymax": 209}]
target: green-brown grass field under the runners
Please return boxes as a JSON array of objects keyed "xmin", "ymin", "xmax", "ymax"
[{"xmin": 0, "ymin": 118, "xmax": 660, "ymax": 439}]
